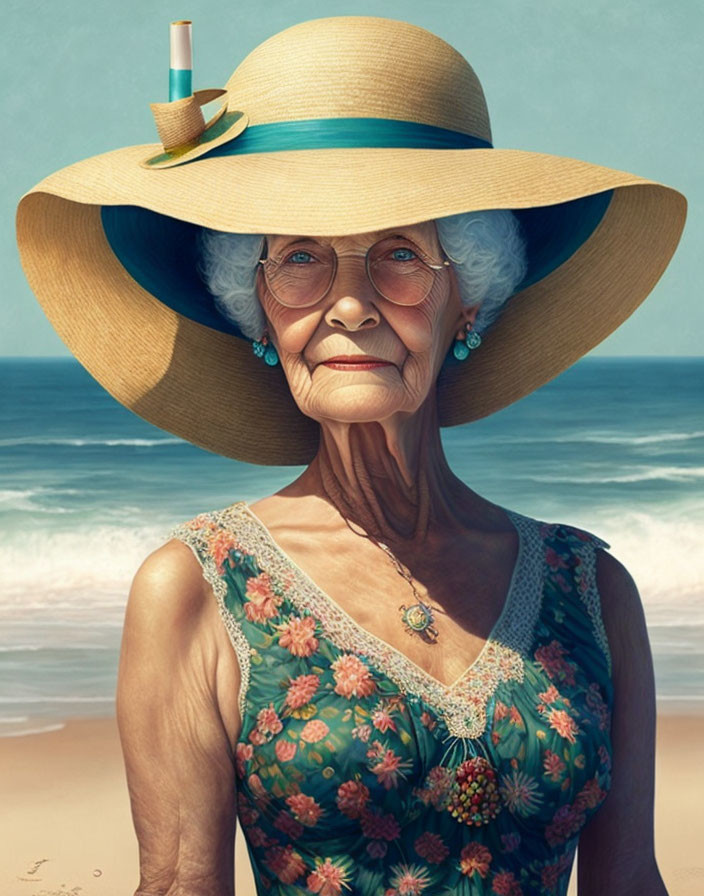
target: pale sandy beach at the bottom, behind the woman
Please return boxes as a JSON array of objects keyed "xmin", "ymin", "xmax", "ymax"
[{"xmin": 0, "ymin": 711, "xmax": 704, "ymax": 896}]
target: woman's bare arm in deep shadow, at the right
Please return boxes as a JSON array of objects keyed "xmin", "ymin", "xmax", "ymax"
[{"xmin": 577, "ymin": 550, "xmax": 667, "ymax": 896}]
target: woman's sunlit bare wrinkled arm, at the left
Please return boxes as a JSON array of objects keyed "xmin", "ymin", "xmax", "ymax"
[{"xmin": 117, "ymin": 540, "xmax": 239, "ymax": 896}]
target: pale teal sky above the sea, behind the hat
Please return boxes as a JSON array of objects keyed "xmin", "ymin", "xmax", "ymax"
[{"xmin": 0, "ymin": 0, "xmax": 704, "ymax": 356}]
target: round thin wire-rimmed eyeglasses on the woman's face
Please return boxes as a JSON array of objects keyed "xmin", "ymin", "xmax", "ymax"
[{"xmin": 259, "ymin": 236, "xmax": 450, "ymax": 308}]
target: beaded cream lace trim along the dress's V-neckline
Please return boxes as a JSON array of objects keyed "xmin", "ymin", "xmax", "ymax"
[{"xmin": 223, "ymin": 501, "xmax": 544, "ymax": 737}]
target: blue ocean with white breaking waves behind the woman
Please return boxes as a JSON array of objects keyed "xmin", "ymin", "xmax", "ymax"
[{"xmin": 0, "ymin": 358, "xmax": 704, "ymax": 736}]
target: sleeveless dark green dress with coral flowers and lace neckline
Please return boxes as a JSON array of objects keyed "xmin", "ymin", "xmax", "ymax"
[{"xmin": 171, "ymin": 502, "xmax": 613, "ymax": 896}]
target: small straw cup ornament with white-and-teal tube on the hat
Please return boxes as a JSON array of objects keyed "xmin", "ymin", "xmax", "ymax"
[{"xmin": 141, "ymin": 20, "xmax": 248, "ymax": 169}]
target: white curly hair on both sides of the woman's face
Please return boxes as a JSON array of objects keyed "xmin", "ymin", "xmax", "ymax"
[{"xmin": 198, "ymin": 209, "xmax": 527, "ymax": 339}]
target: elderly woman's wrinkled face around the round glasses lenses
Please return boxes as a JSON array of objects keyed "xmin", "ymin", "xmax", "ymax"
[{"xmin": 257, "ymin": 221, "xmax": 478, "ymax": 423}]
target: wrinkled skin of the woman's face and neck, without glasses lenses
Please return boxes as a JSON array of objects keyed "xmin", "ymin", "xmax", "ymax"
[{"xmin": 257, "ymin": 221, "xmax": 498, "ymax": 544}]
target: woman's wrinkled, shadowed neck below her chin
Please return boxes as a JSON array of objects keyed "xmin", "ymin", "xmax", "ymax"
[{"xmin": 298, "ymin": 394, "xmax": 472, "ymax": 546}]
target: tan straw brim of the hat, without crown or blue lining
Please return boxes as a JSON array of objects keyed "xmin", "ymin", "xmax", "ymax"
[{"xmin": 17, "ymin": 146, "xmax": 686, "ymax": 464}]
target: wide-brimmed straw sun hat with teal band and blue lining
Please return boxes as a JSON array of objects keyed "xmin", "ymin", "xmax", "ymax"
[{"xmin": 17, "ymin": 16, "xmax": 686, "ymax": 464}]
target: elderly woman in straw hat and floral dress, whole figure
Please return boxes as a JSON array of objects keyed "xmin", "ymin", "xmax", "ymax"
[{"xmin": 18, "ymin": 17, "xmax": 684, "ymax": 896}]
